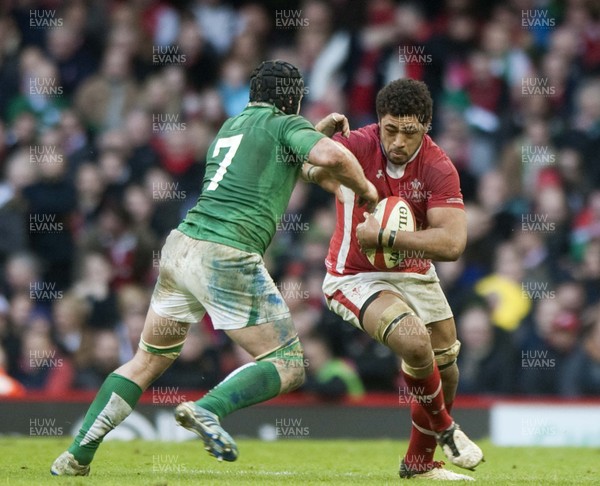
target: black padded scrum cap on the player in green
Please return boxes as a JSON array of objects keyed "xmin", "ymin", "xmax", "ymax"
[{"xmin": 250, "ymin": 60, "xmax": 304, "ymax": 115}]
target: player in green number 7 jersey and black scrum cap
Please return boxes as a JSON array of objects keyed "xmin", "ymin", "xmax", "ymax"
[{"xmin": 51, "ymin": 61, "xmax": 378, "ymax": 476}]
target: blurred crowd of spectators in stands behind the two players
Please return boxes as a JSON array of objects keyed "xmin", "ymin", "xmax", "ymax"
[{"xmin": 0, "ymin": 0, "xmax": 600, "ymax": 399}]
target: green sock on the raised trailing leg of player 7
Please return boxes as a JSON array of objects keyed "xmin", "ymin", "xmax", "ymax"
[{"xmin": 196, "ymin": 361, "xmax": 281, "ymax": 419}]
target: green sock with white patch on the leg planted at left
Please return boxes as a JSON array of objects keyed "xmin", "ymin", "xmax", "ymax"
[{"xmin": 68, "ymin": 373, "xmax": 142, "ymax": 465}]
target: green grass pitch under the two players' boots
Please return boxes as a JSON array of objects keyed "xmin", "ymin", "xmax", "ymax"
[{"xmin": 0, "ymin": 437, "xmax": 600, "ymax": 486}]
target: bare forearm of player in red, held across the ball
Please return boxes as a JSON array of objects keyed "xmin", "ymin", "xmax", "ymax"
[{"xmin": 382, "ymin": 228, "xmax": 466, "ymax": 262}]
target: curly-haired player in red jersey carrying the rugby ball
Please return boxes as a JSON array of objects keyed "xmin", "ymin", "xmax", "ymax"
[{"xmin": 309, "ymin": 79, "xmax": 483, "ymax": 480}]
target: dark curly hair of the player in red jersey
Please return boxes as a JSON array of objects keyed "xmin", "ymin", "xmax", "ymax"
[{"xmin": 375, "ymin": 79, "xmax": 433, "ymax": 124}]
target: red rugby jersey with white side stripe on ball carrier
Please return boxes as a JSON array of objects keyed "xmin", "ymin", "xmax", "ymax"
[{"xmin": 325, "ymin": 123, "xmax": 464, "ymax": 276}]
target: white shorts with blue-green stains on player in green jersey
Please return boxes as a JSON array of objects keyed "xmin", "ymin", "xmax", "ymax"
[{"xmin": 150, "ymin": 229, "xmax": 290, "ymax": 330}]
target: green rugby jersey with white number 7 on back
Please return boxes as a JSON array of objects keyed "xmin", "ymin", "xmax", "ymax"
[{"xmin": 178, "ymin": 105, "xmax": 324, "ymax": 255}]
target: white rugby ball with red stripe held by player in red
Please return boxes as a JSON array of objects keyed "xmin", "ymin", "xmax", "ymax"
[{"xmin": 365, "ymin": 196, "xmax": 417, "ymax": 270}]
